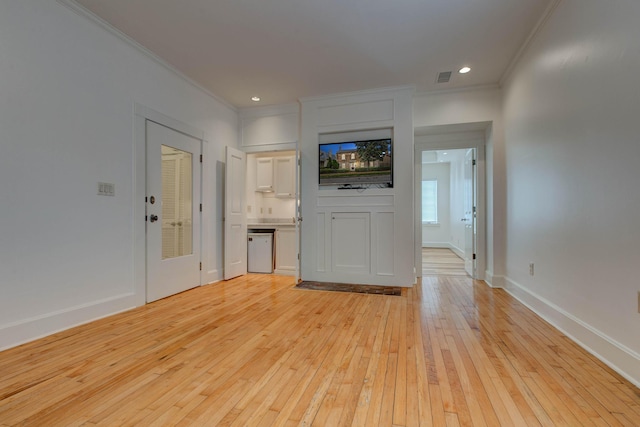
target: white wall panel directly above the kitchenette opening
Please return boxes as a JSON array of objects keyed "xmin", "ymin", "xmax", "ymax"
[{"xmin": 240, "ymin": 104, "xmax": 300, "ymax": 151}]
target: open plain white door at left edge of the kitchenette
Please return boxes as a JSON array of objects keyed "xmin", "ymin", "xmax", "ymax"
[{"xmin": 224, "ymin": 147, "xmax": 247, "ymax": 280}]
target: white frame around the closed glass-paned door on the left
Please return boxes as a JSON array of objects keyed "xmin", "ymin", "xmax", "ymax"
[{"xmin": 132, "ymin": 103, "xmax": 210, "ymax": 305}]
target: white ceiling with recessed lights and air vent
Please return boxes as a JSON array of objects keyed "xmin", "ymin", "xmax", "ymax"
[{"xmin": 76, "ymin": 0, "xmax": 553, "ymax": 107}]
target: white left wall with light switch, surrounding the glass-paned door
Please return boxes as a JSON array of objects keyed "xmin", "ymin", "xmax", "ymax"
[{"xmin": 0, "ymin": 0, "xmax": 238, "ymax": 348}]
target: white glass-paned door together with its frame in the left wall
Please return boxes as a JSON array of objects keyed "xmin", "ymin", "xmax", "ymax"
[{"xmin": 133, "ymin": 104, "xmax": 206, "ymax": 305}]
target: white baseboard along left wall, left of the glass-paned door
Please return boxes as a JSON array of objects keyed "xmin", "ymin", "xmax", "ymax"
[{"xmin": 0, "ymin": 294, "xmax": 139, "ymax": 351}]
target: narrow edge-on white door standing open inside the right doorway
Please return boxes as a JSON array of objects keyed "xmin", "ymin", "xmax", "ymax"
[{"xmin": 464, "ymin": 148, "xmax": 476, "ymax": 277}]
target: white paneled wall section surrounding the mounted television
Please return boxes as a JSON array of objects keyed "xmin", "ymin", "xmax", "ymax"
[{"xmin": 301, "ymin": 87, "xmax": 415, "ymax": 286}]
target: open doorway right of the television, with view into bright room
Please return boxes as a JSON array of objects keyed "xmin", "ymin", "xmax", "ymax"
[{"xmin": 415, "ymin": 124, "xmax": 486, "ymax": 279}]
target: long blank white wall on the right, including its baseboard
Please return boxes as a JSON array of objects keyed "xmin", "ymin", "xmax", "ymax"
[{"xmin": 504, "ymin": 0, "xmax": 640, "ymax": 385}]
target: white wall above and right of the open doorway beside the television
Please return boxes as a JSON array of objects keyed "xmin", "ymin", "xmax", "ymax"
[{"xmin": 413, "ymin": 88, "xmax": 506, "ymax": 287}]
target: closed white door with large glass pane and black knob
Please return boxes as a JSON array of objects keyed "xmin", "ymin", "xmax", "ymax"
[{"xmin": 146, "ymin": 120, "xmax": 202, "ymax": 302}]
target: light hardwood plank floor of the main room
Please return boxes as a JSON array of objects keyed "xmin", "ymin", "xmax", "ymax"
[{"xmin": 0, "ymin": 275, "xmax": 640, "ymax": 426}]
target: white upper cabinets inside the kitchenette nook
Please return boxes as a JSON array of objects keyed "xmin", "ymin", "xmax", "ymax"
[{"xmin": 256, "ymin": 156, "xmax": 296, "ymax": 198}]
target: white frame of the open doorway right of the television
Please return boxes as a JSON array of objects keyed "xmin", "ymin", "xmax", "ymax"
[{"xmin": 414, "ymin": 122, "xmax": 491, "ymax": 280}]
